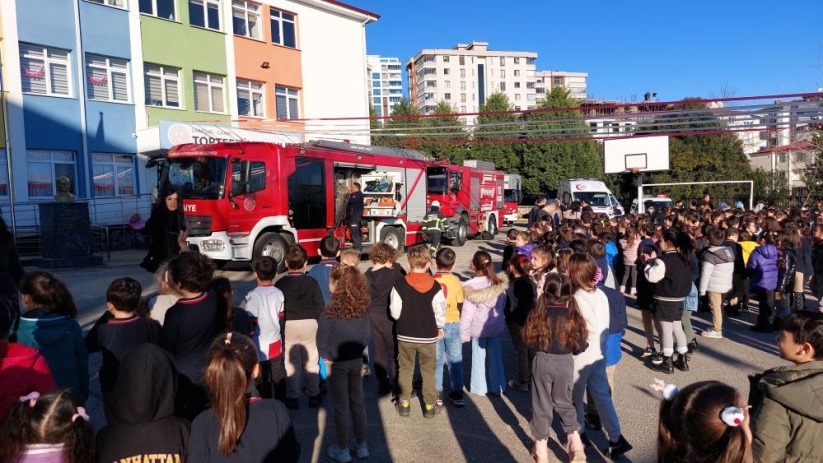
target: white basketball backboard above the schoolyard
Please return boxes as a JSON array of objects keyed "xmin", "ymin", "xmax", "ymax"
[{"xmin": 603, "ymin": 136, "xmax": 669, "ymax": 174}]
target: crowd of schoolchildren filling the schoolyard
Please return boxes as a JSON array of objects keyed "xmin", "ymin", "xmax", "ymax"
[{"xmin": 0, "ymin": 202, "xmax": 823, "ymax": 463}]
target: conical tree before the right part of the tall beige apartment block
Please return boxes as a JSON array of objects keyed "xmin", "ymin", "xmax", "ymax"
[{"xmin": 468, "ymin": 93, "xmax": 521, "ymax": 173}]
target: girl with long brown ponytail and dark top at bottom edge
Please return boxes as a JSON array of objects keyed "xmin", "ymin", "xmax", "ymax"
[{"xmin": 186, "ymin": 333, "xmax": 300, "ymax": 462}]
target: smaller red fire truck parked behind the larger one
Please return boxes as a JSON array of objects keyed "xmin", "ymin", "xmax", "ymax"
[{"xmin": 427, "ymin": 160, "xmax": 504, "ymax": 246}]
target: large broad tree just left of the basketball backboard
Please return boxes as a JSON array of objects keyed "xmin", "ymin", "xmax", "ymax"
[{"xmin": 520, "ymin": 87, "xmax": 603, "ymax": 195}]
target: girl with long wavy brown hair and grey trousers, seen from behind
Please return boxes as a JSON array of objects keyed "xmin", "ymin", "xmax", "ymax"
[{"xmin": 523, "ymin": 273, "xmax": 589, "ymax": 463}]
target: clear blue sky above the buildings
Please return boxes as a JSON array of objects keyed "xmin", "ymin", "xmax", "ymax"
[{"xmin": 358, "ymin": 0, "xmax": 823, "ymax": 101}]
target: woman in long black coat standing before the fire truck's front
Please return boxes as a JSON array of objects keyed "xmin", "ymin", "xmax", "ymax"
[{"xmin": 140, "ymin": 186, "xmax": 188, "ymax": 273}]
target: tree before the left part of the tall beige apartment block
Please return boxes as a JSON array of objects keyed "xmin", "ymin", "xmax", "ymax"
[{"xmin": 417, "ymin": 101, "xmax": 469, "ymax": 164}]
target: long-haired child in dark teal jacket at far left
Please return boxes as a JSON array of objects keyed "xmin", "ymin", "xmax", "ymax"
[{"xmin": 17, "ymin": 272, "xmax": 89, "ymax": 402}]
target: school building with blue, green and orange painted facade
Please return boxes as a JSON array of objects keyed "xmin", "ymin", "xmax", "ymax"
[{"xmin": 0, "ymin": 0, "xmax": 378, "ymax": 230}]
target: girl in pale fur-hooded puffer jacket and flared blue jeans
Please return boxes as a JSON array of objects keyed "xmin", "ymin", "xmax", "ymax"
[{"xmin": 460, "ymin": 251, "xmax": 509, "ymax": 396}]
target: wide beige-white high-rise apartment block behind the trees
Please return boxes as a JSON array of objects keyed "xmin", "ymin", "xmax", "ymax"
[{"xmin": 406, "ymin": 42, "xmax": 537, "ymax": 119}]
